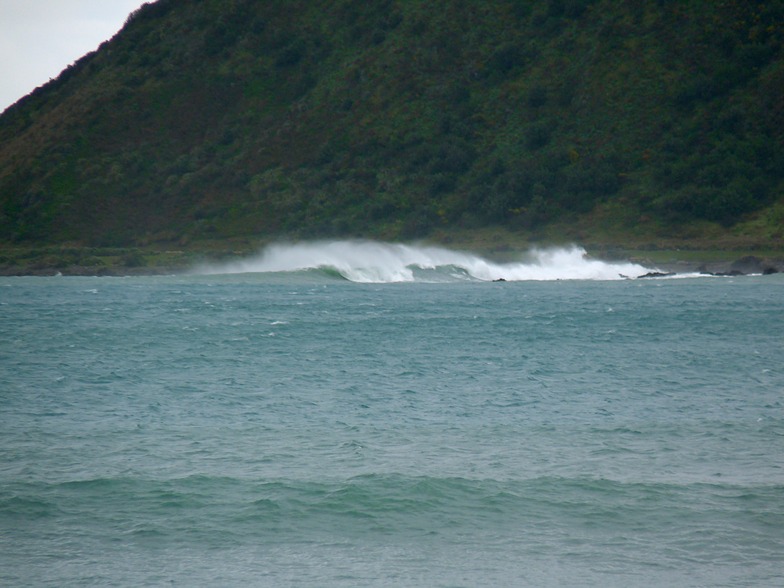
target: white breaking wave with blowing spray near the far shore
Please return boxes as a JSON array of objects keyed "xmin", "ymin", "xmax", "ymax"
[{"xmin": 198, "ymin": 241, "xmax": 650, "ymax": 283}]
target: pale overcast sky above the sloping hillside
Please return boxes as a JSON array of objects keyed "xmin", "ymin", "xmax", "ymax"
[{"xmin": 0, "ymin": 0, "xmax": 145, "ymax": 112}]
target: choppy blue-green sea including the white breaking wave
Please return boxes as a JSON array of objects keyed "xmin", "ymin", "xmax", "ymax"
[{"xmin": 0, "ymin": 243, "xmax": 784, "ymax": 587}]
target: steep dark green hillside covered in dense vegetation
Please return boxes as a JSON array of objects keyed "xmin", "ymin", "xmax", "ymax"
[{"xmin": 0, "ymin": 0, "xmax": 784, "ymax": 247}]
